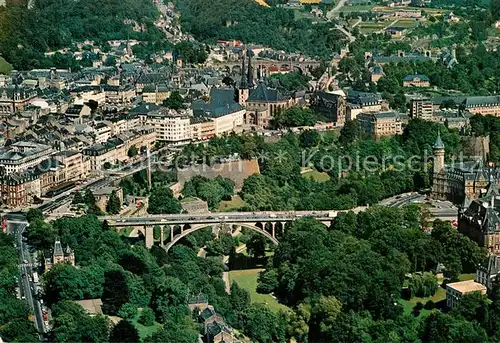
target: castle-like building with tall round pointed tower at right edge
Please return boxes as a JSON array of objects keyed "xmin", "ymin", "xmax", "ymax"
[{"xmin": 432, "ymin": 133, "xmax": 500, "ymax": 204}]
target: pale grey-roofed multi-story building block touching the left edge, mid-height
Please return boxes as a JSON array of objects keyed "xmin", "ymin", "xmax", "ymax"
[{"xmin": 0, "ymin": 142, "xmax": 54, "ymax": 173}]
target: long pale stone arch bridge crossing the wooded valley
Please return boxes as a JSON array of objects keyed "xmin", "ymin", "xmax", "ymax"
[{"xmin": 101, "ymin": 207, "xmax": 365, "ymax": 252}]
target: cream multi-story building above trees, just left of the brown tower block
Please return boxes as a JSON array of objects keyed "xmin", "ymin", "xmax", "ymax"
[{"xmin": 357, "ymin": 112, "xmax": 403, "ymax": 139}]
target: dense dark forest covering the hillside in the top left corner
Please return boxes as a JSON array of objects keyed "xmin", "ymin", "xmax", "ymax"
[{"xmin": 0, "ymin": 0, "xmax": 163, "ymax": 69}]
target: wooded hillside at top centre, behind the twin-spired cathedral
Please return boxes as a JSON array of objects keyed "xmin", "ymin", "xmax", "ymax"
[{"xmin": 171, "ymin": 0, "xmax": 344, "ymax": 58}]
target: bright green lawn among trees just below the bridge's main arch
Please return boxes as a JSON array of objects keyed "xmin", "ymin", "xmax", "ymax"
[{"xmin": 229, "ymin": 269, "xmax": 289, "ymax": 312}]
